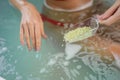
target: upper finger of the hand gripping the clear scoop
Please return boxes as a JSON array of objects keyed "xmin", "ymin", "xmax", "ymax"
[{"xmin": 99, "ymin": 3, "xmax": 119, "ymax": 20}]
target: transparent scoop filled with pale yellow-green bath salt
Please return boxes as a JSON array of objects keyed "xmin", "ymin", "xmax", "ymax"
[{"xmin": 64, "ymin": 17, "xmax": 99, "ymax": 43}]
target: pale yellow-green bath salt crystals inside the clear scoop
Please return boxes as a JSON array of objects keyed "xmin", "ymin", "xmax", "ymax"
[{"xmin": 64, "ymin": 27, "xmax": 93, "ymax": 42}]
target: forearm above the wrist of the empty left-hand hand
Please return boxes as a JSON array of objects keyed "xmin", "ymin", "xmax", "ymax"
[{"xmin": 10, "ymin": 0, "xmax": 28, "ymax": 11}]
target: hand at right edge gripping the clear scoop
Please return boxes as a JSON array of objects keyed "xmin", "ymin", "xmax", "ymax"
[{"xmin": 98, "ymin": 0, "xmax": 120, "ymax": 25}]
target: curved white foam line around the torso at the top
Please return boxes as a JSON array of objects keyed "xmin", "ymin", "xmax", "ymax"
[{"xmin": 44, "ymin": 0, "xmax": 93, "ymax": 12}]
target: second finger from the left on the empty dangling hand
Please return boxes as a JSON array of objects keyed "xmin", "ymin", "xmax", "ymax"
[{"xmin": 23, "ymin": 24, "xmax": 31, "ymax": 50}]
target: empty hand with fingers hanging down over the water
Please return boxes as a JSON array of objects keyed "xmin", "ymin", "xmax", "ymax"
[{"xmin": 20, "ymin": 3, "xmax": 46, "ymax": 51}]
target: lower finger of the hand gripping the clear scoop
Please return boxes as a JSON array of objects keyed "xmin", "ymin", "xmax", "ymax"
[{"xmin": 100, "ymin": 7, "xmax": 120, "ymax": 25}]
